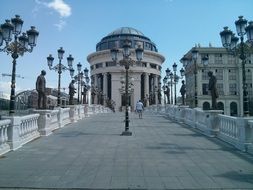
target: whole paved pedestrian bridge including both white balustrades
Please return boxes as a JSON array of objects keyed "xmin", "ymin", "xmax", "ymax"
[{"xmin": 0, "ymin": 105, "xmax": 253, "ymax": 189}]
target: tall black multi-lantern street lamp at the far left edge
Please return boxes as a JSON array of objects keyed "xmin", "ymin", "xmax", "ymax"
[{"xmin": 0, "ymin": 15, "xmax": 39, "ymax": 115}]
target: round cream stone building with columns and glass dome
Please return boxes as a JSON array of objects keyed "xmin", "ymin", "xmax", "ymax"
[{"xmin": 87, "ymin": 27, "xmax": 165, "ymax": 111}]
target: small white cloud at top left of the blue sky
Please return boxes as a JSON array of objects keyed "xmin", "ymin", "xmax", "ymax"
[{"xmin": 46, "ymin": 0, "xmax": 71, "ymax": 17}]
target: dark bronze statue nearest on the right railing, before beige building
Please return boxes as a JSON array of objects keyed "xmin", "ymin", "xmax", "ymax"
[{"xmin": 208, "ymin": 71, "xmax": 219, "ymax": 110}]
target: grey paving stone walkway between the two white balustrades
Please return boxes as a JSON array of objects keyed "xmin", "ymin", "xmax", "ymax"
[{"xmin": 0, "ymin": 112, "xmax": 253, "ymax": 190}]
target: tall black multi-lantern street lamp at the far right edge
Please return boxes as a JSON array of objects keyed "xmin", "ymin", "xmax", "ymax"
[{"xmin": 220, "ymin": 16, "xmax": 253, "ymax": 116}]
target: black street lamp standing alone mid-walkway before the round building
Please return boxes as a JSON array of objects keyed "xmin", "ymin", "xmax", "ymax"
[{"xmin": 111, "ymin": 39, "xmax": 143, "ymax": 136}]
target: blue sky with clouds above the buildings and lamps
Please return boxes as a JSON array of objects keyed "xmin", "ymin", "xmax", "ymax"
[{"xmin": 0, "ymin": 0, "xmax": 253, "ymax": 98}]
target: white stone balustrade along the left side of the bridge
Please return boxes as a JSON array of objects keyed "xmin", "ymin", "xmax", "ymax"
[{"xmin": 0, "ymin": 105, "xmax": 111, "ymax": 155}]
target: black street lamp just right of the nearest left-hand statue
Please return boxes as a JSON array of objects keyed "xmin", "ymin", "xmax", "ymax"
[{"xmin": 47, "ymin": 47, "xmax": 74, "ymax": 106}]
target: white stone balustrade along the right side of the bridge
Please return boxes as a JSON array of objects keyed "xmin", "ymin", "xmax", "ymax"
[{"xmin": 146, "ymin": 105, "xmax": 253, "ymax": 154}]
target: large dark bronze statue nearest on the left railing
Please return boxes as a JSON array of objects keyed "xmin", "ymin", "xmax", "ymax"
[{"xmin": 36, "ymin": 70, "xmax": 47, "ymax": 109}]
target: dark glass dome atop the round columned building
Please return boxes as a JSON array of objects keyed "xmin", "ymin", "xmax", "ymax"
[{"xmin": 96, "ymin": 27, "xmax": 157, "ymax": 52}]
